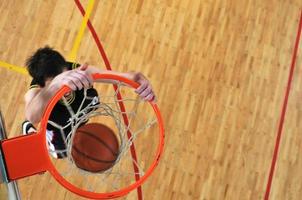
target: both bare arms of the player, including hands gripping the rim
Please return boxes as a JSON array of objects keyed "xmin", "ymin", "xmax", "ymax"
[{"xmin": 25, "ymin": 65, "xmax": 155, "ymax": 123}]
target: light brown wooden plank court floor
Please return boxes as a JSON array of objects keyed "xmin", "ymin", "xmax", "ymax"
[{"xmin": 0, "ymin": 0, "xmax": 302, "ymax": 200}]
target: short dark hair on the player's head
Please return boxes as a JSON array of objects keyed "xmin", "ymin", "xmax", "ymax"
[{"xmin": 26, "ymin": 46, "xmax": 66, "ymax": 87}]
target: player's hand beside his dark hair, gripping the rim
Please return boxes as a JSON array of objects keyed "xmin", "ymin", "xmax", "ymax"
[{"xmin": 51, "ymin": 64, "xmax": 93, "ymax": 91}]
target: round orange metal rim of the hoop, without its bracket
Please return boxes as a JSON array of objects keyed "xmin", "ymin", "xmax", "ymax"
[{"xmin": 40, "ymin": 74, "xmax": 164, "ymax": 199}]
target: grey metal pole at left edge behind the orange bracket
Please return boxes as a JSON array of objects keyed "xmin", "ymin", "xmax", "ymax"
[{"xmin": 0, "ymin": 111, "xmax": 21, "ymax": 200}]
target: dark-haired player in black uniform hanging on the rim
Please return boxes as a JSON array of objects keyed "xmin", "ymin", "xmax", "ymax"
[{"xmin": 22, "ymin": 46, "xmax": 155, "ymax": 158}]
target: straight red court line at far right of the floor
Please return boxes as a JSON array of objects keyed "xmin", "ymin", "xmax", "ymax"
[{"xmin": 264, "ymin": 11, "xmax": 302, "ymax": 200}]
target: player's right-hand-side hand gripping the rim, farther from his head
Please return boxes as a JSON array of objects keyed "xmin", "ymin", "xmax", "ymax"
[{"xmin": 133, "ymin": 73, "xmax": 156, "ymax": 102}]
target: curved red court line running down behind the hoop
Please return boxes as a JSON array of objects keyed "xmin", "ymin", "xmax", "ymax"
[{"xmin": 74, "ymin": 0, "xmax": 143, "ymax": 200}]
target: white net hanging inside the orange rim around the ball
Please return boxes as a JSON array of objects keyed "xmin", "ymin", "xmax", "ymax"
[{"xmin": 48, "ymin": 83, "xmax": 159, "ymax": 193}]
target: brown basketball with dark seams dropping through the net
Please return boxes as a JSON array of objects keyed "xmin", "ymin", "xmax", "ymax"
[{"xmin": 71, "ymin": 123, "xmax": 119, "ymax": 173}]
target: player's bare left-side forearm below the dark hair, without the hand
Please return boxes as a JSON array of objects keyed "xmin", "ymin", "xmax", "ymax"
[{"xmin": 25, "ymin": 85, "xmax": 60, "ymax": 124}]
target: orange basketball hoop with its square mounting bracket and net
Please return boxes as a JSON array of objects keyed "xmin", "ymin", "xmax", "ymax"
[{"xmin": 2, "ymin": 74, "xmax": 164, "ymax": 199}]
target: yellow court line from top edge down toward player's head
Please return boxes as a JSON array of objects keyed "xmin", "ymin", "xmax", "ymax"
[{"xmin": 68, "ymin": 0, "xmax": 94, "ymax": 62}]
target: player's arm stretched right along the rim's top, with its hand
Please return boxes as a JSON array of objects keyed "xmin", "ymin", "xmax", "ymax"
[{"xmin": 84, "ymin": 64, "xmax": 156, "ymax": 101}]
